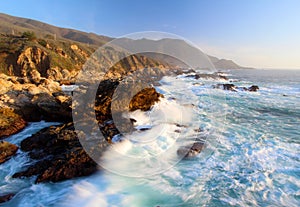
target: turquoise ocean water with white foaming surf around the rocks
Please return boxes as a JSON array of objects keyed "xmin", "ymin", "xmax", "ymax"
[{"xmin": 0, "ymin": 70, "xmax": 300, "ymax": 207}]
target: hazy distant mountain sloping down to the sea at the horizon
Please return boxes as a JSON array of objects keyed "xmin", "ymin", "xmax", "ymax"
[{"xmin": 114, "ymin": 38, "xmax": 246, "ymax": 69}]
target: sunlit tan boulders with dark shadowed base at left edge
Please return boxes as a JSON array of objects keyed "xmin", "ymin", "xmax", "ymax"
[{"xmin": 0, "ymin": 74, "xmax": 72, "ymax": 122}]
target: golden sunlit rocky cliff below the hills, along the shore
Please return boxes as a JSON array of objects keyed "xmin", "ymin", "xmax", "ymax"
[{"xmin": 0, "ymin": 34, "xmax": 170, "ymax": 83}]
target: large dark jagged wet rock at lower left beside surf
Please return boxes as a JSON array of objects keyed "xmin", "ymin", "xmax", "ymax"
[{"xmin": 13, "ymin": 123, "xmax": 98, "ymax": 183}]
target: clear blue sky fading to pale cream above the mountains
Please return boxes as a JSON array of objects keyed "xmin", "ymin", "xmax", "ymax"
[{"xmin": 0, "ymin": 0, "xmax": 300, "ymax": 69}]
